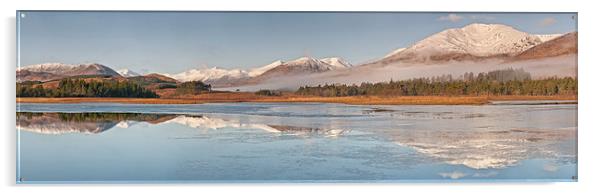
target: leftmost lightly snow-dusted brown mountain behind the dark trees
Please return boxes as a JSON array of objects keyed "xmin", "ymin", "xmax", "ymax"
[{"xmin": 17, "ymin": 63, "xmax": 120, "ymax": 81}]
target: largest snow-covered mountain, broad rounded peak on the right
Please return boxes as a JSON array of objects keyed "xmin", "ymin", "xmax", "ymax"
[{"xmin": 383, "ymin": 24, "xmax": 560, "ymax": 63}]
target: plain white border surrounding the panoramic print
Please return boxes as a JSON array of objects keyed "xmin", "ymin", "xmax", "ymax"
[{"xmin": 0, "ymin": 0, "xmax": 602, "ymax": 195}]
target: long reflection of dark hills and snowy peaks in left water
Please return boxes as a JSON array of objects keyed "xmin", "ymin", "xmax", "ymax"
[{"xmin": 17, "ymin": 112, "xmax": 349, "ymax": 136}]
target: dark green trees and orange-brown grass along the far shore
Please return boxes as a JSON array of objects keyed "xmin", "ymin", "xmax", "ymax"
[{"xmin": 16, "ymin": 69, "xmax": 577, "ymax": 105}]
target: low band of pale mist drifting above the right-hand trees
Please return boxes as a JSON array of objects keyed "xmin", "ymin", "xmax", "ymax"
[{"xmin": 216, "ymin": 55, "xmax": 577, "ymax": 91}]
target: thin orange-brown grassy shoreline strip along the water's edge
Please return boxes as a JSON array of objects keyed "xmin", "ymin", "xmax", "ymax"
[{"xmin": 16, "ymin": 94, "xmax": 578, "ymax": 105}]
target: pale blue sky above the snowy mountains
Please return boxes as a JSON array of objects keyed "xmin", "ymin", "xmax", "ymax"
[{"xmin": 18, "ymin": 11, "xmax": 577, "ymax": 73}]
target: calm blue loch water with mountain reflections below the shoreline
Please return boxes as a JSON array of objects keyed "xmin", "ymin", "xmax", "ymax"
[{"xmin": 16, "ymin": 103, "xmax": 577, "ymax": 183}]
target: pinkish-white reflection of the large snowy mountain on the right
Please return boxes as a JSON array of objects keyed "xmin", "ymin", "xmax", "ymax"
[{"xmin": 393, "ymin": 129, "xmax": 576, "ymax": 169}]
